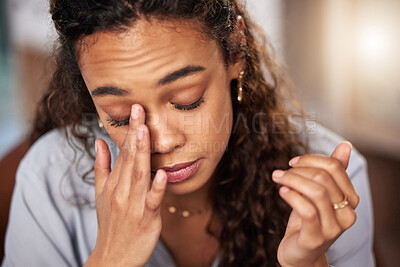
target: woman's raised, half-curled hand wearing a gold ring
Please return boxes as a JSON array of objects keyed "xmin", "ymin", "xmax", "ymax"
[{"xmin": 272, "ymin": 142, "xmax": 359, "ymax": 267}]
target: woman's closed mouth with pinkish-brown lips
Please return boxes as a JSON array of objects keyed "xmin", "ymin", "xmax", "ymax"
[{"xmin": 151, "ymin": 159, "xmax": 200, "ymax": 183}]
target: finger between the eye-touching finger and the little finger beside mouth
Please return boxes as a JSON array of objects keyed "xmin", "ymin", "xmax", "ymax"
[{"xmin": 129, "ymin": 124, "xmax": 151, "ymax": 208}]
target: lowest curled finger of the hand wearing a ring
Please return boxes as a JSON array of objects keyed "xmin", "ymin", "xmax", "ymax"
[{"xmin": 279, "ymin": 186, "xmax": 321, "ymax": 244}]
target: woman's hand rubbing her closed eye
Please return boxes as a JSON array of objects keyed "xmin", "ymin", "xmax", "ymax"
[{"xmin": 86, "ymin": 105, "xmax": 167, "ymax": 266}]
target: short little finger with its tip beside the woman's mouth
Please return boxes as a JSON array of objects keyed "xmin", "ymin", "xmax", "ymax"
[{"xmin": 143, "ymin": 172, "xmax": 167, "ymax": 220}]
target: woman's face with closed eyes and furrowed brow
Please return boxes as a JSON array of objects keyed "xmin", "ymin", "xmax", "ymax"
[{"xmin": 79, "ymin": 20, "xmax": 244, "ymax": 194}]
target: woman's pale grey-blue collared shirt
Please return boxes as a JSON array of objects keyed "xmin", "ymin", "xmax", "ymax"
[{"xmin": 2, "ymin": 125, "xmax": 375, "ymax": 267}]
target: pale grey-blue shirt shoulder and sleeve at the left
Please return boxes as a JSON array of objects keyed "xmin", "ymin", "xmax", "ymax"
[{"xmin": 6, "ymin": 126, "xmax": 106, "ymax": 266}]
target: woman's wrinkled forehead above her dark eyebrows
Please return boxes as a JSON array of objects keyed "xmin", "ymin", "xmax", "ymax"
[{"xmin": 79, "ymin": 20, "xmax": 222, "ymax": 90}]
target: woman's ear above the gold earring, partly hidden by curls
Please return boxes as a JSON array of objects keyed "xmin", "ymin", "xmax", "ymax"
[{"xmin": 228, "ymin": 16, "xmax": 247, "ymax": 80}]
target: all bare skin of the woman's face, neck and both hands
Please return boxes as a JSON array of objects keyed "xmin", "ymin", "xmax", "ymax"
[{"xmin": 79, "ymin": 16, "xmax": 358, "ymax": 267}]
